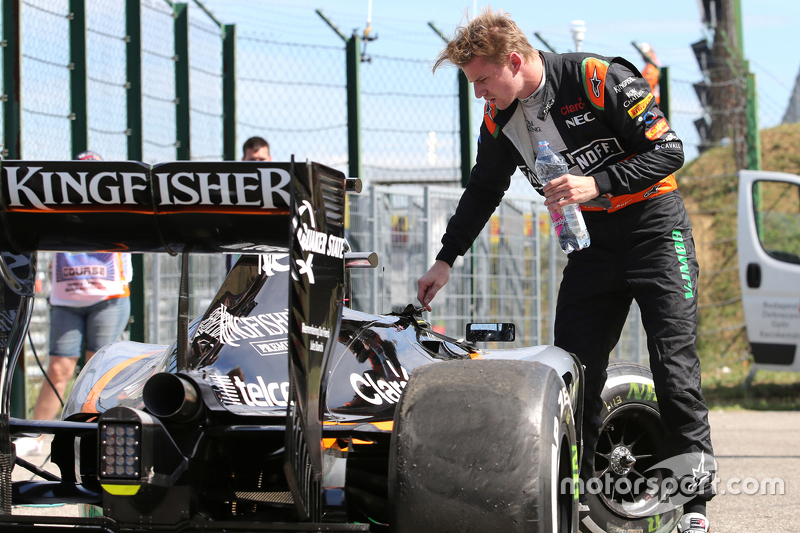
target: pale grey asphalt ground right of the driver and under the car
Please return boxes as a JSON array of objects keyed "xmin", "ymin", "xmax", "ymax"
[{"xmin": 7, "ymin": 411, "xmax": 800, "ymax": 533}]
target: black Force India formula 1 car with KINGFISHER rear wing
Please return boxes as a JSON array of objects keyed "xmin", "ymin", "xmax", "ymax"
[{"xmin": 0, "ymin": 160, "xmax": 680, "ymax": 533}]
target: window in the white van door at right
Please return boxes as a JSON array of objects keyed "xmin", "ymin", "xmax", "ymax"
[{"xmin": 753, "ymin": 181, "xmax": 800, "ymax": 264}]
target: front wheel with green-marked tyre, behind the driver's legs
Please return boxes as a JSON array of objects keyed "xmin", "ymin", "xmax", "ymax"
[{"xmin": 580, "ymin": 362, "xmax": 683, "ymax": 533}]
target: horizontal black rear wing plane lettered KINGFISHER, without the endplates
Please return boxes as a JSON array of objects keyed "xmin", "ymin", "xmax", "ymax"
[{"xmin": 0, "ymin": 161, "xmax": 300, "ymax": 254}]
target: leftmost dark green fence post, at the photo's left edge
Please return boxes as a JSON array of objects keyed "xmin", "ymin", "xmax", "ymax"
[{"xmin": 3, "ymin": 0, "xmax": 22, "ymax": 159}]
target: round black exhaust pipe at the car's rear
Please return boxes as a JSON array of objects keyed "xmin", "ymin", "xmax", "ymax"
[{"xmin": 142, "ymin": 372, "xmax": 203, "ymax": 422}]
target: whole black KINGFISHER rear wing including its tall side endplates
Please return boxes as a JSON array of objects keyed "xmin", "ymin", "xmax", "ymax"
[{"xmin": 0, "ymin": 161, "xmax": 352, "ymax": 520}]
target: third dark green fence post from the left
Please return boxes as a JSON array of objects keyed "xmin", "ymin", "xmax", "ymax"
[{"xmin": 125, "ymin": 0, "xmax": 145, "ymax": 342}]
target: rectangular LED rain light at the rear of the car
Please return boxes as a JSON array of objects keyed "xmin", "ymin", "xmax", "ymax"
[{"xmin": 100, "ymin": 424, "xmax": 142, "ymax": 479}]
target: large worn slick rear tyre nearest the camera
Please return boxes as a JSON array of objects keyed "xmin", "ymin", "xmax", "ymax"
[{"xmin": 389, "ymin": 360, "xmax": 578, "ymax": 533}]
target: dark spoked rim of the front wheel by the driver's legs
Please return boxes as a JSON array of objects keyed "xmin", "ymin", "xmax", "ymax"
[{"xmin": 590, "ymin": 404, "xmax": 664, "ymax": 518}]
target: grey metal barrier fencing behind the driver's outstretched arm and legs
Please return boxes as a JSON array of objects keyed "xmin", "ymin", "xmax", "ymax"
[{"xmin": 346, "ymin": 186, "xmax": 647, "ymax": 363}]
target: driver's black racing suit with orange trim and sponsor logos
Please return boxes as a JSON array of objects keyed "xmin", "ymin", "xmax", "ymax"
[{"xmin": 437, "ymin": 52, "xmax": 713, "ymax": 499}]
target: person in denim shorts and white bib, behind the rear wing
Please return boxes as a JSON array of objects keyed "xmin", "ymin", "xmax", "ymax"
[{"xmin": 15, "ymin": 152, "xmax": 133, "ymax": 455}]
